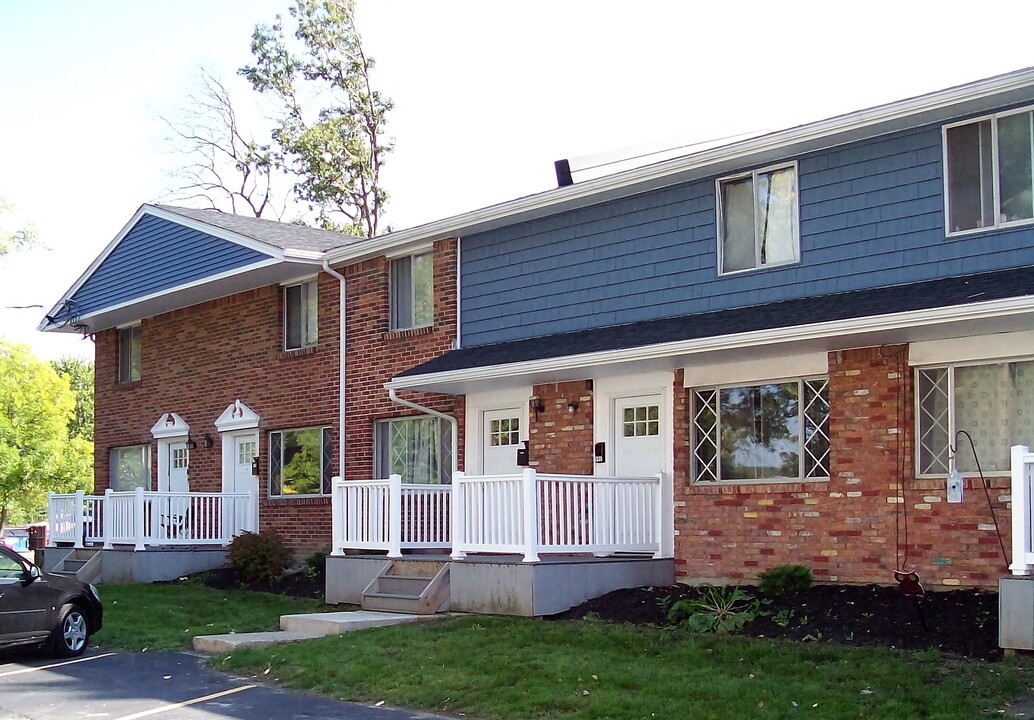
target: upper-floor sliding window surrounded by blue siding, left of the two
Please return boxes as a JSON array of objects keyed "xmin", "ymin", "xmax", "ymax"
[{"xmin": 718, "ymin": 163, "xmax": 800, "ymax": 274}]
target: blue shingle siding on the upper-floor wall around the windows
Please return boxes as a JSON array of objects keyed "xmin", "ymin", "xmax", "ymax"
[{"xmin": 461, "ymin": 119, "xmax": 1034, "ymax": 347}]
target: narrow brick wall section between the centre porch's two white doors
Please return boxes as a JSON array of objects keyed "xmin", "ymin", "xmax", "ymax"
[{"xmin": 528, "ymin": 380, "xmax": 594, "ymax": 475}]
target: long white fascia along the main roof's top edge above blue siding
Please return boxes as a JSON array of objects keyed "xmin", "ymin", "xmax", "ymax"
[{"xmin": 328, "ymin": 68, "xmax": 1034, "ymax": 255}]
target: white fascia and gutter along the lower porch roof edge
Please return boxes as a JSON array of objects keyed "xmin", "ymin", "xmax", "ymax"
[{"xmin": 385, "ymin": 296, "xmax": 1034, "ymax": 390}]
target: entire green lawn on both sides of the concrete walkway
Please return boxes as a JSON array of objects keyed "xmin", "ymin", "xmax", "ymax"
[{"xmin": 96, "ymin": 584, "xmax": 1031, "ymax": 720}]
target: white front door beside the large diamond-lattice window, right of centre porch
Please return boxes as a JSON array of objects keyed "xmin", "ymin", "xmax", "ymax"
[{"xmin": 613, "ymin": 395, "xmax": 665, "ymax": 478}]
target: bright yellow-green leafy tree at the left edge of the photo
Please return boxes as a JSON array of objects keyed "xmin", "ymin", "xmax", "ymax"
[{"xmin": 0, "ymin": 340, "xmax": 93, "ymax": 529}]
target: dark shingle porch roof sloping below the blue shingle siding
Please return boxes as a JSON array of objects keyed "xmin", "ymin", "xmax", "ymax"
[{"xmin": 399, "ymin": 267, "xmax": 1034, "ymax": 378}]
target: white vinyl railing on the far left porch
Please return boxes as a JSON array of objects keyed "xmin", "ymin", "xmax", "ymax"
[{"xmin": 49, "ymin": 487, "xmax": 256, "ymax": 550}]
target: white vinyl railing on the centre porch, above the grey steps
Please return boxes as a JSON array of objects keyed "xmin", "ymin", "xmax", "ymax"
[{"xmin": 332, "ymin": 469, "xmax": 665, "ymax": 563}]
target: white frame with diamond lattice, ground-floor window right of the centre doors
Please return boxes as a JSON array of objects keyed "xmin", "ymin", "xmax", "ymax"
[{"xmin": 688, "ymin": 374, "xmax": 832, "ymax": 486}]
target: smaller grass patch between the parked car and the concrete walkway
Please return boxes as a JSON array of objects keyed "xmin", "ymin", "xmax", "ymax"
[{"xmin": 94, "ymin": 582, "xmax": 328, "ymax": 651}]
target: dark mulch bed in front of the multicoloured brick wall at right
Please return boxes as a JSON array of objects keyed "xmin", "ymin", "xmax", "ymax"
[{"xmin": 554, "ymin": 584, "xmax": 1002, "ymax": 660}]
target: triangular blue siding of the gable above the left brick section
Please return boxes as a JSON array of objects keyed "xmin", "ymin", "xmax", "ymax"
[{"xmin": 65, "ymin": 215, "xmax": 269, "ymax": 316}]
